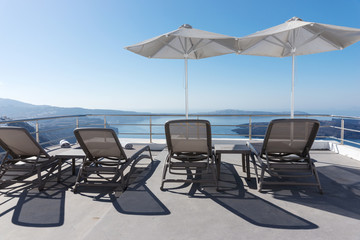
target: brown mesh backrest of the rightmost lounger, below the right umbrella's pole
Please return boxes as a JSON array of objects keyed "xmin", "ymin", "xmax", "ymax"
[{"xmin": 262, "ymin": 119, "xmax": 320, "ymax": 155}]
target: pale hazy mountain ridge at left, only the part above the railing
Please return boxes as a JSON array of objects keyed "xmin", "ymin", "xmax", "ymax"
[{"xmin": 0, "ymin": 98, "xmax": 146, "ymax": 119}]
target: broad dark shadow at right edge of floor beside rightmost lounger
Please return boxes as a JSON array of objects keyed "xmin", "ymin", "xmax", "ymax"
[{"xmin": 271, "ymin": 165, "xmax": 360, "ymax": 219}]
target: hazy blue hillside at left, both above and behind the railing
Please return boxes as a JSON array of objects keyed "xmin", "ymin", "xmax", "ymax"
[{"xmin": 0, "ymin": 98, "xmax": 142, "ymax": 146}]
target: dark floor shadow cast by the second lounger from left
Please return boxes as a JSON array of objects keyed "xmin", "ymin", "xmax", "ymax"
[{"xmin": 112, "ymin": 161, "xmax": 170, "ymax": 215}]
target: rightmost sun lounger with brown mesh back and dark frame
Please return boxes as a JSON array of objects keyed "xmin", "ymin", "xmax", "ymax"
[{"xmin": 249, "ymin": 119, "xmax": 322, "ymax": 193}]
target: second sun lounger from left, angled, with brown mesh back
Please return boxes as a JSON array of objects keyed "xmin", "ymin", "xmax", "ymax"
[{"xmin": 74, "ymin": 128, "xmax": 153, "ymax": 192}]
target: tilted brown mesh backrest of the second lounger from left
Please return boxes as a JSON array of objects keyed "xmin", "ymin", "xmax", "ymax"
[{"xmin": 74, "ymin": 128, "xmax": 126, "ymax": 159}]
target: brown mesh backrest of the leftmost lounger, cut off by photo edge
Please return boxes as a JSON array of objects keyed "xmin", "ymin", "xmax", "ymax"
[{"xmin": 0, "ymin": 127, "xmax": 49, "ymax": 158}]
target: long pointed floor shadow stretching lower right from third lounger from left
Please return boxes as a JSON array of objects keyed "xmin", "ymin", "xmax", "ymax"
[{"xmin": 200, "ymin": 163, "xmax": 318, "ymax": 229}]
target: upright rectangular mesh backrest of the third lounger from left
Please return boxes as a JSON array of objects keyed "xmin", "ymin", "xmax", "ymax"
[{"xmin": 165, "ymin": 120, "xmax": 212, "ymax": 154}]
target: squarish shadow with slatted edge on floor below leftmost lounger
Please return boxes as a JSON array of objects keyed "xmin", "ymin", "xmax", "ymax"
[{"xmin": 0, "ymin": 163, "xmax": 75, "ymax": 227}]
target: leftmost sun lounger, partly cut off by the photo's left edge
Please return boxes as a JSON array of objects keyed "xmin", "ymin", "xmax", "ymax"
[{"xmin": 0, "ymin": 127, "xmax": 59, "ymax": 190}]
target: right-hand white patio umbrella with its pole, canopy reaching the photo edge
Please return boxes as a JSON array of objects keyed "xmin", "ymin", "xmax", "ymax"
[{"xmin": 238, "ymin": 17, "xmax": 360, "ymax": 118}]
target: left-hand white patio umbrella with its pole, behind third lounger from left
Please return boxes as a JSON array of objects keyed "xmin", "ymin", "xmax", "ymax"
[{"xmin": 125, "ymin": 24, "xmax": 237, "ymax": 118}]
